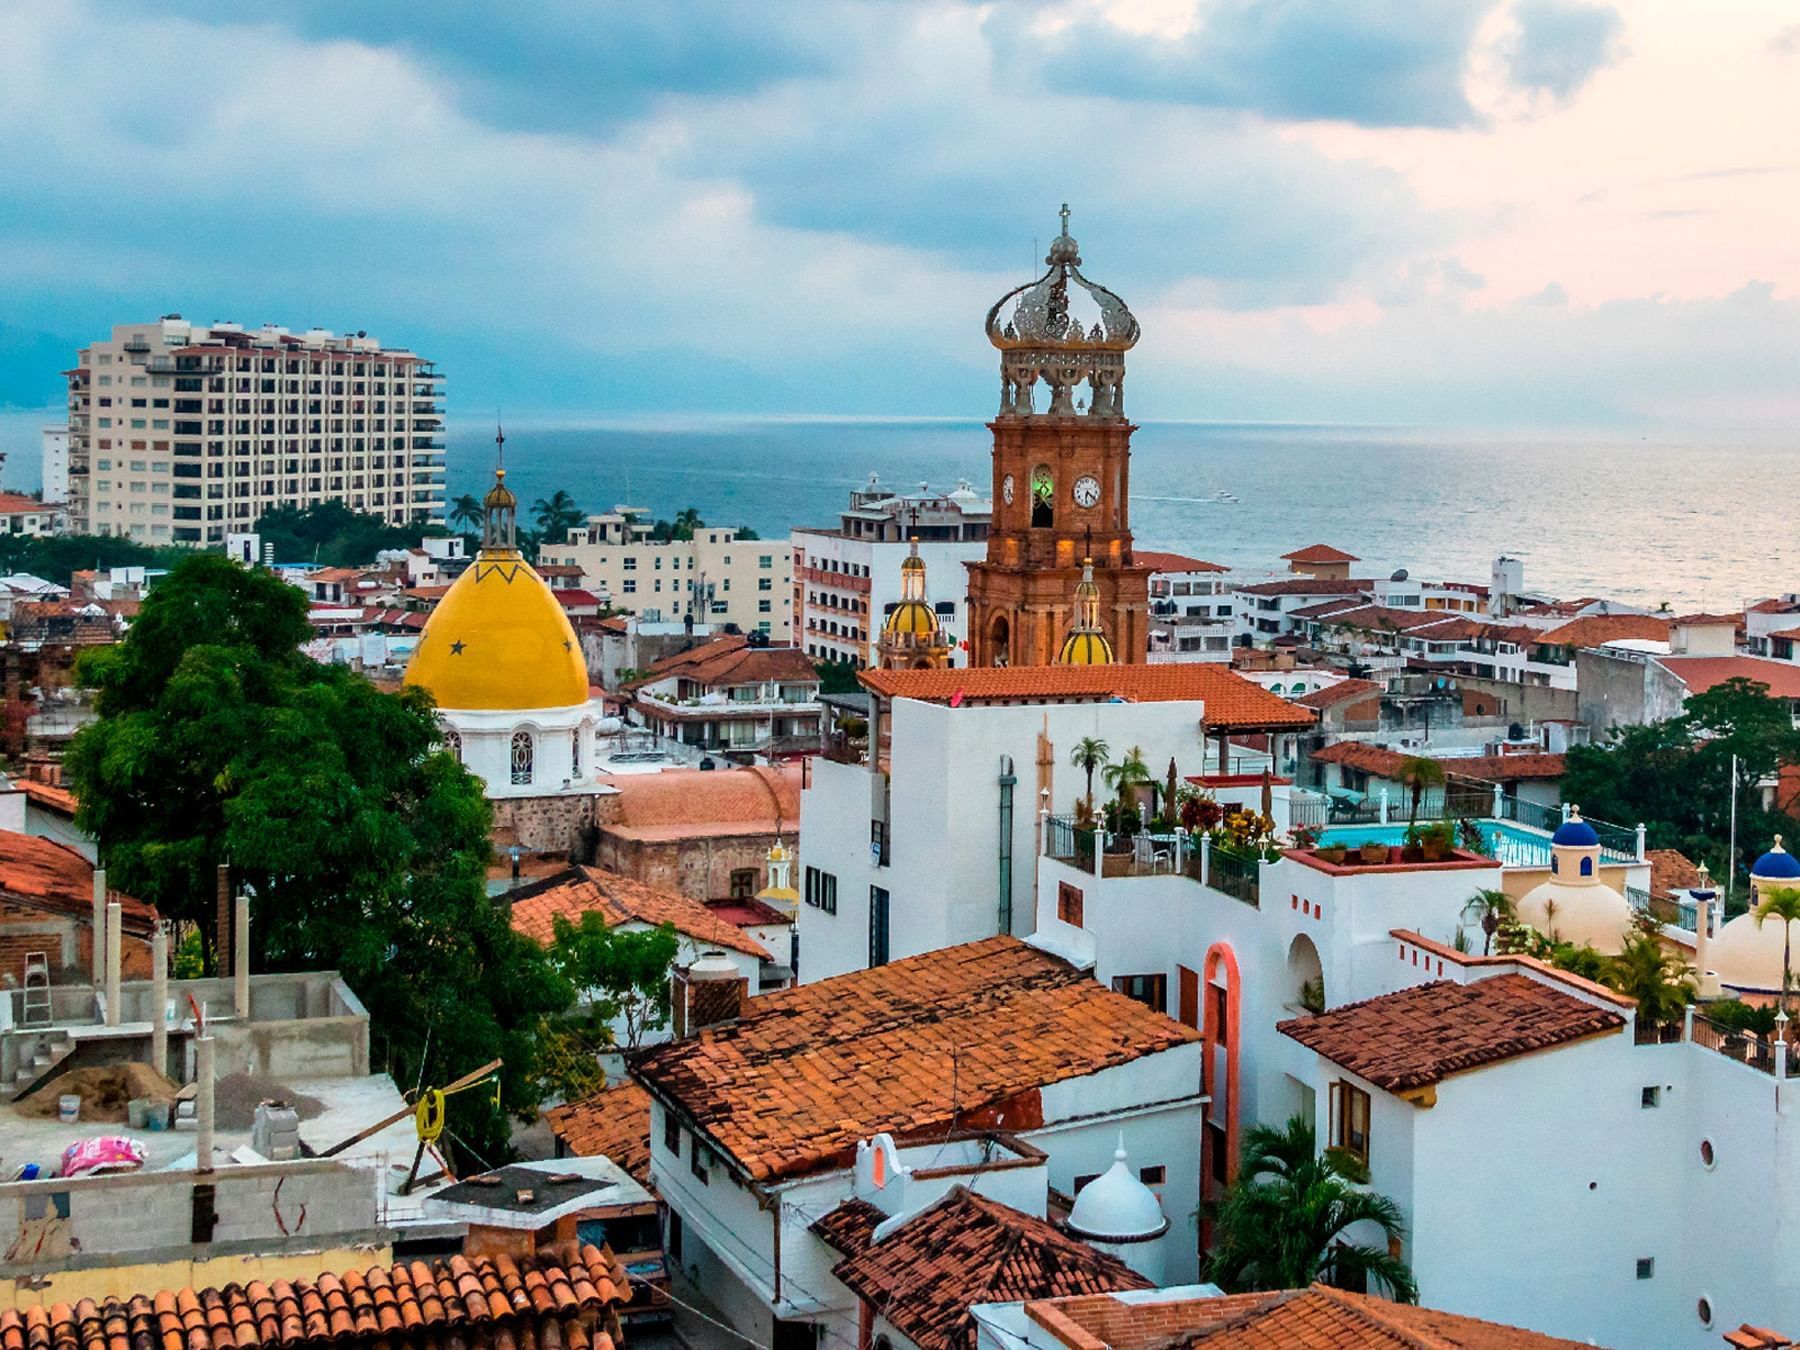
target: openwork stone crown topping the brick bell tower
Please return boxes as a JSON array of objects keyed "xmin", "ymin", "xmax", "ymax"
[{"xmin": 986, "ymin": 202, "xmax": 1141, "ymax": 418}]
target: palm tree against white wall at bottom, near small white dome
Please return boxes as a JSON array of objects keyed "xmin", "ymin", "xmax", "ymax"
[{"xmin": 1206, "ymin": 1116, "xmax": 1418, "ymax": 1303}]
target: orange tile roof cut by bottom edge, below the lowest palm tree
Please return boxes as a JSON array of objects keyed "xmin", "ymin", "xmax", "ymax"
[{"xmin": 1024, "ymin": 1285, "xmax": 1579, "ymax": 1350}]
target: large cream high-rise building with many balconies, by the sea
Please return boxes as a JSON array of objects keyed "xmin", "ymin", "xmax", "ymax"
[{"xmin": 67, "ymin": 315, "xmax": 445, "ymax": 545}]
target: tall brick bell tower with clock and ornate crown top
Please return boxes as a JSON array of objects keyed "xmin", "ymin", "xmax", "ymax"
[{"xmin": 968, "ymin": 205, "xmax": 1150, "ymax": 666}]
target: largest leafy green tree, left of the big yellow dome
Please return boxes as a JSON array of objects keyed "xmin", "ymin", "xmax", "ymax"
[{"xmin": 65, "ymin": 553, "xmax": 572, "ymax": 1157}]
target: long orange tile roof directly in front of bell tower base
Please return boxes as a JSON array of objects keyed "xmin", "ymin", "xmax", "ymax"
[{"xmin": 857, "ymin": 661, "xmax": 1317, "ymax": 729}]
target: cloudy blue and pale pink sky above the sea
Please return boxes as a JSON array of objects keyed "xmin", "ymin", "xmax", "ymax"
[{"xmin": 0, "ymin": 0, "xmax": 1800, "ymax": 437}]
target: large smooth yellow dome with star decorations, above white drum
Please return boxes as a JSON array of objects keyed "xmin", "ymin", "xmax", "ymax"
[{"xmin": 407, "ymin": 554, "xmax": 587, "ymax": 711}]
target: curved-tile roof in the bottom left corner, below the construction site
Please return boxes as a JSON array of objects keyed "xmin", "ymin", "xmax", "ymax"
[{"xmin": 0, "ymin": 1246, "xmax": 630, "ymax": 1350}]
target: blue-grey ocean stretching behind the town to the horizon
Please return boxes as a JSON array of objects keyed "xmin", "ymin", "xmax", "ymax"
[{"xmin": 0, "ymin": 412, "xmax": 1800, "ymax": 610}]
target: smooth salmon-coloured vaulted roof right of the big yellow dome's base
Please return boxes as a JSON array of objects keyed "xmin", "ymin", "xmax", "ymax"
[{"xmin": 599, "ymin": 765, "xmax": 801, "ymax": 839}]
